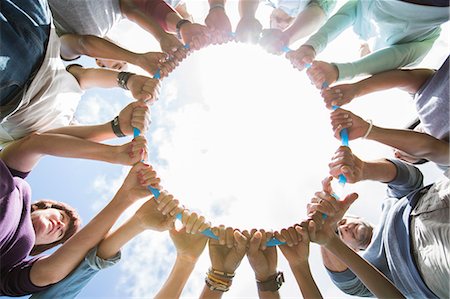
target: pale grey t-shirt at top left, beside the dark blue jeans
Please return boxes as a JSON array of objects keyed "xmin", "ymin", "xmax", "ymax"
[{"xmin": 48, "ymin": 0, "xmax": 122, "ymax": 37}]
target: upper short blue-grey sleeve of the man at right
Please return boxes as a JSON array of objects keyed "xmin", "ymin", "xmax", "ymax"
[{"xmin": 387, "ymin": 159, "xmax": 423, "ymax": 198}]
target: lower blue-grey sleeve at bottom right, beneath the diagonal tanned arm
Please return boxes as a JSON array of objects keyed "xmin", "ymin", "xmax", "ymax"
[{"xmin": 327, "ymin": 269, "xmax": 373, "ymax": 297}]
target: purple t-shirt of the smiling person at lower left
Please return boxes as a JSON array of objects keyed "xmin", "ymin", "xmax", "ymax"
[{"xmin": 0, "ymin": 159, "xmax": 46, "ymax": 296}]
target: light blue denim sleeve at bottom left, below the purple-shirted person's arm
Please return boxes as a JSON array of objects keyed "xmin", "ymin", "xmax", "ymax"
[{"xmin": 30, "ymin": 247, "xmax": 121, "ymax": 299}]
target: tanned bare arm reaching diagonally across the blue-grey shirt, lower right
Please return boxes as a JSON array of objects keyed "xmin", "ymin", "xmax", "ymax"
[{"xmin": 308, "ymin": 221, "xmax": 404, "ymax": 298}]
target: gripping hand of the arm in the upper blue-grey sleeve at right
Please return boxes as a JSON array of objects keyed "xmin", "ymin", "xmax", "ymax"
[{"xmin": 328, "ymin": 146, "xmax": 366, "ymax": 184}]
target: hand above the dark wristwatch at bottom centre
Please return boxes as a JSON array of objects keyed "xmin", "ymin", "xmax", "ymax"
[{"xmin": 243, "ymin": 230, "xmax": 277, "ymax": 281}]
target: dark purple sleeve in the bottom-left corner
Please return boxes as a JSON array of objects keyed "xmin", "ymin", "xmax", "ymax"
[{"xmin": 0, "ymin": 257, "xmax": 48, "ymax": 297}]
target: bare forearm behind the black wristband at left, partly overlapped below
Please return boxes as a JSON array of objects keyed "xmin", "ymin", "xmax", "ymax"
[{"xmin": 46, "ymin": 122, "xmax": 117, "ymax": 142}]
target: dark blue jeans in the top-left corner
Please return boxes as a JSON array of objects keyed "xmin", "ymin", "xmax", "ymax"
[{"xmin": 0, "ymin": 0, "xmax": 51, "ymax": 106}]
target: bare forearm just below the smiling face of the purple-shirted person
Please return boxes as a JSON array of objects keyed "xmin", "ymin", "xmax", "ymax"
[{"xmin": 30, "ymin": 191, "xmax": 130, "ymax": 286}]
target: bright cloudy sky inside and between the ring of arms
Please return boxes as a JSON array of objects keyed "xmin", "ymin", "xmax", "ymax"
[{"xmin": 22, "ymin": 1, "xmax": 449, "ymax": 298}]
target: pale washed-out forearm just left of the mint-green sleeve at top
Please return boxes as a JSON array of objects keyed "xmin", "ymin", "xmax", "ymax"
[{"xmin": 284, "ymin": 5, "xmax": 326, "ymax": 44}]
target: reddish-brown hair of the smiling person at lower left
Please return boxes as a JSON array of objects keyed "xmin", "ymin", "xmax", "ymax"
[{"xmin": 30, "ymin": 199, "xmax": 81, "ymax": 255}]
